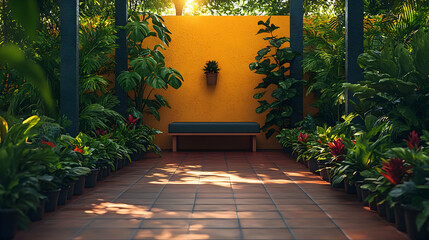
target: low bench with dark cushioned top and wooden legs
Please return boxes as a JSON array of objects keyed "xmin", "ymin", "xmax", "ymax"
[{"xmin": 168, "ymin": 122, "xmax": 260, "ymax": 152}]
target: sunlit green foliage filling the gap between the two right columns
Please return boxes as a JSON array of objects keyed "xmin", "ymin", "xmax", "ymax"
[{"xmin": 303, "ymin": 16, "xmax": 345, "ymax": 125}]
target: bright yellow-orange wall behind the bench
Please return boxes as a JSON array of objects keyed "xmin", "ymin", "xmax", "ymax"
[{"xmin": 145, "ymin": 16, "xmax": 289, "ymax": 149}]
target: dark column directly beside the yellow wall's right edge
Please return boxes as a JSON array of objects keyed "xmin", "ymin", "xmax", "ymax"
[{"xmin": 290, "ymin": 0, "xmax": 304, "ymax": 125}]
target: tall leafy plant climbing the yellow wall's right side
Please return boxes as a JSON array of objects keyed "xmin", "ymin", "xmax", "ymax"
[{"xmin": 249, "ymin": 17, "xmax": 305, "ymax": 138}]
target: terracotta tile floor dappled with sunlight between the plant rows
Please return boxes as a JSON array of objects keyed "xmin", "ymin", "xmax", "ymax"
[{"xmin": 16, "ymin": 151, "xmax": 407, "ymax": 240}]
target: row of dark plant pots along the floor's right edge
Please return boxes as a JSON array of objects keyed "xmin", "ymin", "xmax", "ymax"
[{"xmin": 295, "ymin": 156, "xmax": 429, "ymax": 240}]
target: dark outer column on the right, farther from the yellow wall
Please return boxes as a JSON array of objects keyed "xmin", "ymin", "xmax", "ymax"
[{"xmin": 345, "ymin": 0, "xmax": 364, "ymax": 114}]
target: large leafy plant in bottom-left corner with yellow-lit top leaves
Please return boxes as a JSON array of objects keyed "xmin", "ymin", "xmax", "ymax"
[{"xmin": 0, "ymin": 116, "xmax": 55, "ymax": 239}]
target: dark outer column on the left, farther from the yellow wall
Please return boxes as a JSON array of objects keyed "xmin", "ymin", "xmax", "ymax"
[{"xmin": 60, "ymin": 0, "xmax": 79, "ymax": 136}]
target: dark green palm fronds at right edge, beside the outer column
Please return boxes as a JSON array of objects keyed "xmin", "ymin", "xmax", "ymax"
[{"xmin": 344, "ymin": 31, "xmax": 429, "ymax": 138}]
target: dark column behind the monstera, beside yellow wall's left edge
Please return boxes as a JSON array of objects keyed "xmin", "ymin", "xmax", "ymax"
[{"xmin": 115, "ymin": 0, "xmax": 128, "ymax": 116}]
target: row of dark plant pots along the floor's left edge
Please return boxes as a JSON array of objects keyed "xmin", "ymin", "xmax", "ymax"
[{"xmin": 0, "ymin": 158, "xmax": 135, "ymax": 240}]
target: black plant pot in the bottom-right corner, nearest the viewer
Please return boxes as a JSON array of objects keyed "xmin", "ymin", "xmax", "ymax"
[{"xmin": 403, "ymin": 206, "xmax": 429, "ymax": 240}]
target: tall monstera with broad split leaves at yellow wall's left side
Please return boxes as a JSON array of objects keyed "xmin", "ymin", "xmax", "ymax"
[{"xmin": 117, "ymin": 13, "xmax": 183, "ymax": 120}]
